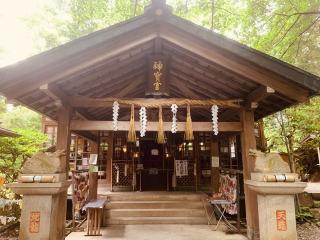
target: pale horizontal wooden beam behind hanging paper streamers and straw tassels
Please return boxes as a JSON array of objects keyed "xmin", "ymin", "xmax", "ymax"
[{"xmin": 71, "ymin": 120, "xmax": 242, "ymax": 132}]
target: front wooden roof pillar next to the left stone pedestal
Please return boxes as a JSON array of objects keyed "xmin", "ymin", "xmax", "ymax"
[{"xmin": 56, "ymin": 106, "xmax": 72, "ymax": 239}]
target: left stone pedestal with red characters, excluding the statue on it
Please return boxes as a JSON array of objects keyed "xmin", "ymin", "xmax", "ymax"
[{"xmin": 7, "ymin": 181, "xmax": 71, "ymax": 240}]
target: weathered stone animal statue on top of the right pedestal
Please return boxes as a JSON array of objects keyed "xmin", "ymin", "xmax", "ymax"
[{"xmin": 249, "ymin": 149, "xmax": 291, "ymax": 173}]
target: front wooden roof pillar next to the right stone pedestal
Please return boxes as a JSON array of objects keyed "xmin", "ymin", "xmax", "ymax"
[{"xmin": 240, "ymin": 109, "xmax": 259, "ymax": 239}]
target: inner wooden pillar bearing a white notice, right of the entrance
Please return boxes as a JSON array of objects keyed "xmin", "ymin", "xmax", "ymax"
[{"xmin": 211, "ymin": 140, "xmax": 220, "ymax": 192}]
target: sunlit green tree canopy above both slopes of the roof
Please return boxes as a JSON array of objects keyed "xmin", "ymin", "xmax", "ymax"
[{"xmin": 25, "ymin": 0, "xmax": 320, "ymax": 75}]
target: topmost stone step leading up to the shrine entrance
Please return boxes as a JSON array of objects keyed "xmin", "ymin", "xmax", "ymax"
[{"xmin": 104, "ymin": 192, "xmax": 202, "ymax": 201}]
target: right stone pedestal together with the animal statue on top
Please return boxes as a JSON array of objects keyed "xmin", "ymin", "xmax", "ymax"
[{"xmin": 245, "ymin": 151, "xmax": 307, "ymax": 240}]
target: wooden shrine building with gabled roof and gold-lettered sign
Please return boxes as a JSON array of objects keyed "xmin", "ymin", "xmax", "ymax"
[{"xmin": 0, "ymin": 0, "xmax": 320, "ymax": 240}]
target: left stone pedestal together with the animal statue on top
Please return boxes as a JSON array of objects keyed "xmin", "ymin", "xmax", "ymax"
[{"xmin": 7, "ymin": 151, "xmax": 71, "ymax": 240}]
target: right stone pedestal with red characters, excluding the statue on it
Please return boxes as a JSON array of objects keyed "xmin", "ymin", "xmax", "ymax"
[{"xmin": 245, "ymin": 176, "xmax": 306, "ymax": 240}]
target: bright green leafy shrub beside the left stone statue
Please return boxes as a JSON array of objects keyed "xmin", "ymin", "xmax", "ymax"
[{"xmin": 0, "ymin": 129, "xmax": 47, "ymax": 183}]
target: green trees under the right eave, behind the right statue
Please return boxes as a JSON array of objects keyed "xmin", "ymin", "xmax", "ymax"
[{"xmin": 264, "ymin": 97, "xmax": 320, "ymax": 174}]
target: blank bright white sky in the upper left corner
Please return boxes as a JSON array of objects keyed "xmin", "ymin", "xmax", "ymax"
[{"xmin": 0, "ymin": 0, "xmax": 51, "ymax": 67}]
